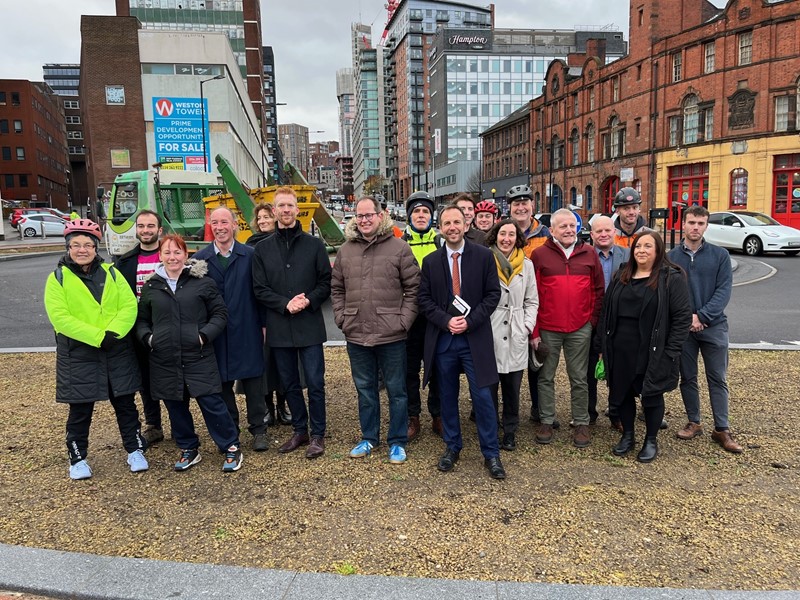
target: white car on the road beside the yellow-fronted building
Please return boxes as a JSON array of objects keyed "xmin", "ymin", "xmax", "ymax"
[{"xmin": 704, "ymin": 210, "xmax": 800, "ymax": 256}]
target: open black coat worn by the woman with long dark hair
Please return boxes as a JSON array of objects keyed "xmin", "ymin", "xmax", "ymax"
[{"xmin": 598, "ymin": 266, "xmax": 692, "ymax": 396}]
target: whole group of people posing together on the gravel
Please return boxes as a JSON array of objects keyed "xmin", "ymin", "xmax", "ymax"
[{"xmin": 45, "ymin": 185, "xmax": 742, "ymax": 479}]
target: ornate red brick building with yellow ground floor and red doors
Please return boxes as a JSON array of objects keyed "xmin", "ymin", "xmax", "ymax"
[{"xmin": 483, "ymin": 0, "xmax": 800, "ymax": 230}]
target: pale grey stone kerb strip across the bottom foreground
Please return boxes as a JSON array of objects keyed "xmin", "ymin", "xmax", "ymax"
[{"xmin": 0, "ymin": 544, "xmax": 798, "ymax": 600}]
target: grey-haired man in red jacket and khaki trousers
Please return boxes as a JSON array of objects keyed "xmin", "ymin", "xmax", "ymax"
[{"xmin": 531, "ymin": 208, "xmax": 605, "ymax": 448}]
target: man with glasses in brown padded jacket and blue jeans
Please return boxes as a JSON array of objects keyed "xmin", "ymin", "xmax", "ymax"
[{"xmin": 331, "ymin": 196, "xmax": 420, "ymax": 464}]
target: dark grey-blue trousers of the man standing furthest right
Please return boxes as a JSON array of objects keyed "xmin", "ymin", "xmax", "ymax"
[{"xmin": 681, "ymin": 321, "xmax": 729, "ymax": 429}]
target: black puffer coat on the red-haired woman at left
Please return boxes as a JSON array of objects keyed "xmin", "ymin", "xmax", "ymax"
[{"xmin": 136, "ymin": 260, "xmax": 228, "ymax": 400}]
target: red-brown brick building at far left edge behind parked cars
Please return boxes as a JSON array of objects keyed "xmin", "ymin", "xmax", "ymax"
[{"xmin": 0, "ymin": 79, "xmax": 69, "ymax": 210}]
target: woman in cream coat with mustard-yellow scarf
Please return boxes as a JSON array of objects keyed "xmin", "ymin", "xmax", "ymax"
[{"xmin": 486, "ymin": 219, "xmax": 539, "ymax": 450}]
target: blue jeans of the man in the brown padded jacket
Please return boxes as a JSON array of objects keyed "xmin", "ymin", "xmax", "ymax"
[{"xmin": 347, "ymin": 340, "xmax": 408, "ymax": 447}]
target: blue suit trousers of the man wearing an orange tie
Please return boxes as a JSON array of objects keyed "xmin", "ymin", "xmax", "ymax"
[{"xmin": 434, "ymin": 332, "xmax": 500, "ymax": 458}]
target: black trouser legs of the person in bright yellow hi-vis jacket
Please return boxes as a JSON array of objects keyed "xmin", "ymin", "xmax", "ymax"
[{"xmin": 67, "ymin": 390, "xmax": 147, "ymax": 465}]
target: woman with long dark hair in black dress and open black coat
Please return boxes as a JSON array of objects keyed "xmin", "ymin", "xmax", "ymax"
[{"xmin": 599, "ymin": 231, "xmax": 692, "ymax": 463}]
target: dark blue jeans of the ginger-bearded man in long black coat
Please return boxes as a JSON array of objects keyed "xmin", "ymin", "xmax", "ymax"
[{"xmin": 271, "ymin": 344, "xmax": 325, "ymax": 437}]
